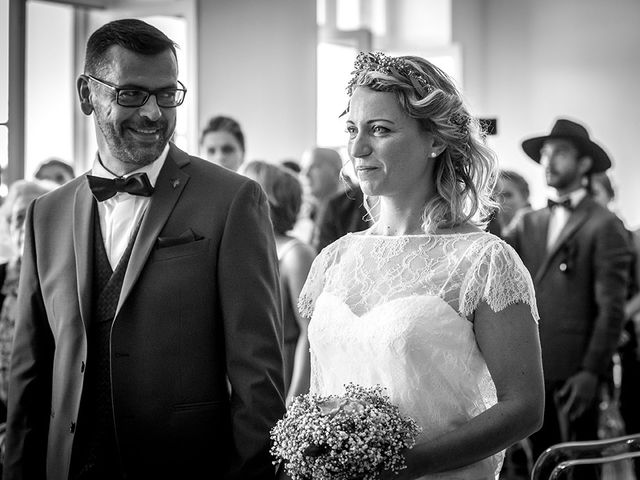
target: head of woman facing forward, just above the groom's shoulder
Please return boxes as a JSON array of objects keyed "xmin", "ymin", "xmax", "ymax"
[{"xmin": 200, "ymin": 115, "xmax": 245, "ymax": 172}]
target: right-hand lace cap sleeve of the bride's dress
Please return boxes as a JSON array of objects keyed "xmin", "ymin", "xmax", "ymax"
[{"xmin": 460, "ymin": 240, "xmax": 540, "ymax": 322}]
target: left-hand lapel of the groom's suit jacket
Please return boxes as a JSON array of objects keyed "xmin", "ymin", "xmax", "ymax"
[{"xmin": 73, "ymin": 181, "xmax": 94, "ymax": 327}]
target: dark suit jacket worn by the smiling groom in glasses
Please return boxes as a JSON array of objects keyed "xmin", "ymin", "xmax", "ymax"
[{"xmin": 4, "ymin": 145, "xmax": 284, "ymax": 480}]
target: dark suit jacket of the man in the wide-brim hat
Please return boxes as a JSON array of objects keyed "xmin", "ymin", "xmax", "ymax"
[{"xmin": 505, "ymin": 197, "xmax": 632, "ymax": 382}]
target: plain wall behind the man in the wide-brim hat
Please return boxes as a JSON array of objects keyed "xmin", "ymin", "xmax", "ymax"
[{"xmin": 453, "ymin": 0, "xmax": 640, "ymax": 227}]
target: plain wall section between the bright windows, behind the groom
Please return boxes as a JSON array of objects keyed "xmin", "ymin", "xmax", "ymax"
[{"xmin": 198, "ymin": 0, "xmax": 317, "ymax": 161}]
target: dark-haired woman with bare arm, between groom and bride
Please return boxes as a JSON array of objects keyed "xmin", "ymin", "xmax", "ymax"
[{"xmin": 242, "ymin": 160, "xmax": 315, "ymax": 403}]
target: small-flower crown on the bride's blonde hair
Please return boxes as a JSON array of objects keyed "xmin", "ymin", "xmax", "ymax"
[{"xmin": 347, "ymin": 52, "xmax": 434, "ymax": 97}]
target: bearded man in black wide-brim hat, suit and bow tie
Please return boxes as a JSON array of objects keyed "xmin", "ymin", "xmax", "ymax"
[{"xmin": 506, "ymin": 118, "xmax": 632, "ymax": 479}]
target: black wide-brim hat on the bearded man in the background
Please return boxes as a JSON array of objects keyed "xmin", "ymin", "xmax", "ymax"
[{"xmin": 522, "ymin": 118, "xmax": 611, "ymax": 173}]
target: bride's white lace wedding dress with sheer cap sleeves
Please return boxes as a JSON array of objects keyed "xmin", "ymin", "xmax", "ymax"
[{"xmin": 298, "ymin": 232, "xmax": 538, "ymax": 480}]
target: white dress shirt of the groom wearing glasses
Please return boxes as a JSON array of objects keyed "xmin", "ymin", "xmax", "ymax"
[{"xmin": 91, "ymin": 144, "xmax": 169, "ymax": 270}]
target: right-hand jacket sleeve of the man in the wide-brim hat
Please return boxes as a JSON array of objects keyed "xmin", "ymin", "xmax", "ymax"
[{"xmin": 582, "ymin": 216, "xmax": 632, "ymax": 375}]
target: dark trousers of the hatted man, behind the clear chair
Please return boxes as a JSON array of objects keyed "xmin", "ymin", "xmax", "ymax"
[{"xmin": 529, "ymin": 381, "xmax": 600, "ymax": 480}]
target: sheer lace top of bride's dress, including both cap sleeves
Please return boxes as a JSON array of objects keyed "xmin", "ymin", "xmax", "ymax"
[{"xmin": 298, "ymin": 232, "xmax": 538, "ymax": 320}]
